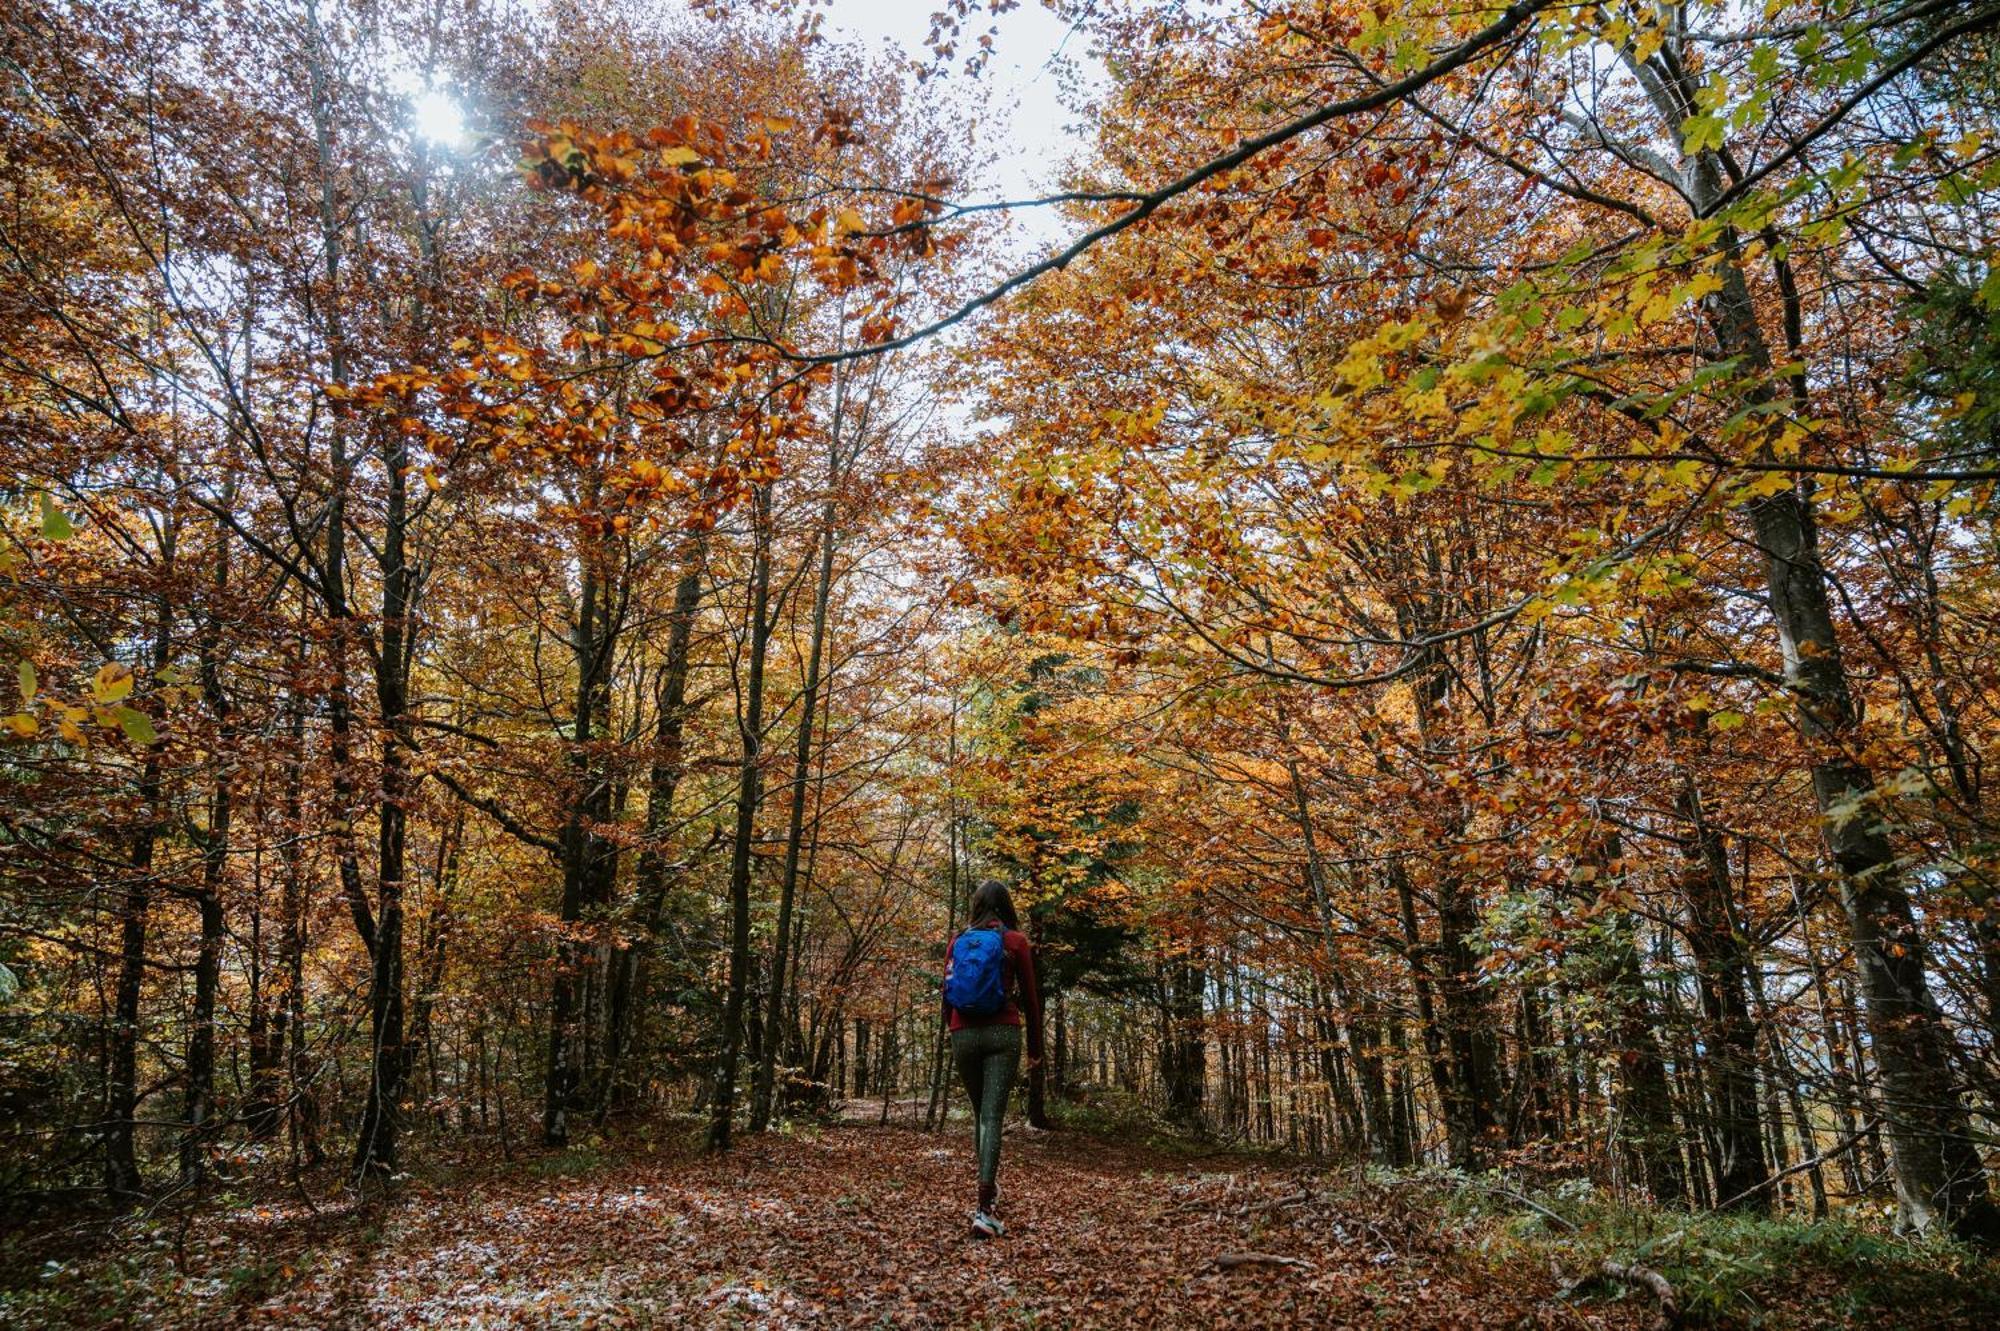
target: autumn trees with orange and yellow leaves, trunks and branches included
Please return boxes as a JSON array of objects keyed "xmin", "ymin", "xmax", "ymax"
[{"xmin": 0, "ymin": 0, "xmax": 2000, "ymax": 1287}]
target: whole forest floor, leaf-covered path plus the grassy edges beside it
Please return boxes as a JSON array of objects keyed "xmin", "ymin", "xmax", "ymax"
[{"xmin": 0, "ymin": 1107, "xmax": 2000, "ymax": 1327}]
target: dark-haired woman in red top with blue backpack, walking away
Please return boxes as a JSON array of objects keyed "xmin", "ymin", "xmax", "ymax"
[{"xmin": 944, "ymin": 879, "xmax": 1042, "ymax": 1239}]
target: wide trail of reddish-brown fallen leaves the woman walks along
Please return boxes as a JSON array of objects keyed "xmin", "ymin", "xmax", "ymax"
[{"xmin": 23, "ymin": 1125, "xmax": 1650, "ymax": 1327}]
